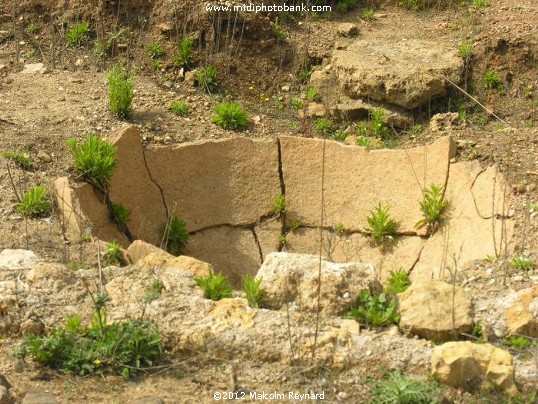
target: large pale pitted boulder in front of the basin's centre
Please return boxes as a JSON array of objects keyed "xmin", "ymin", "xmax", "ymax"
[{"xmin": 257, "ymin": 252, "xmax": 374, "ymax": 315}]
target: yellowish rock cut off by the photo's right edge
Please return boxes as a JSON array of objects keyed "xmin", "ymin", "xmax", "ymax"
[{"xmin": 505, "ymin": 286, "xmax": 538, "ymax": 338}]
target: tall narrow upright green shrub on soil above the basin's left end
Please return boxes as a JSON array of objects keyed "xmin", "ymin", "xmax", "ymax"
[{"xmin": 108, "ymin": 64, "xmax": 134, "ymax": 119}]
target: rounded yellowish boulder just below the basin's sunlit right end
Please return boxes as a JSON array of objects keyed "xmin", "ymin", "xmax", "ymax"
[{"xmin": 398, "ymin": 281, "xmax": 473, "ymax": 341}]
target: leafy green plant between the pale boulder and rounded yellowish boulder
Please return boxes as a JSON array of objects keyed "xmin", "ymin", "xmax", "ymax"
[{"xmin": 346, "ymin": 290, "xmax": 400, "ymax": 327}]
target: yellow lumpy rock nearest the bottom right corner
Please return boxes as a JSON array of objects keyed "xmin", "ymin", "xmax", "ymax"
[{"xmin": 431, "ymin": 341, "xmax": 518, "ymax": 395}]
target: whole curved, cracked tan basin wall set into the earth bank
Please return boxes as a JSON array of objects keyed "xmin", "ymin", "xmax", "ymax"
[{"xmin": 57, "ymin": 126, "xmax": 513, "ymax": 284}]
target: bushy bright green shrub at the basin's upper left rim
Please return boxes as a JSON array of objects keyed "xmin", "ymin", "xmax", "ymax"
[{"xmin": 67, "ymin": 134, "xmax": 117, "ymax": 188}]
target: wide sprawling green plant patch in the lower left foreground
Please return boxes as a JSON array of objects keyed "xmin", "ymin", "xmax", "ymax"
[{"xmin": 15, "ymin": 311, "xmax": 164, "ymax": 379}]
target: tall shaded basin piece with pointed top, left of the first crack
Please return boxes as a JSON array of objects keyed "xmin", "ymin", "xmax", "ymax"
[{"xmin": 110, "ymin": 125, "xmax": 166, "ymax": 244}]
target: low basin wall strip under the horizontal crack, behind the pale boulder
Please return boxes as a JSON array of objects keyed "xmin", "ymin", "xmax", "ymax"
[{"xmin": 284, "ymin": 229, "xmax": 425, "ymax": 282}]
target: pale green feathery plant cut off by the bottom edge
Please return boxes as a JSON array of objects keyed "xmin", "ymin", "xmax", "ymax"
[{"xmin": 371, "ymin": 370, "xmax": 437, "ymax": 404}]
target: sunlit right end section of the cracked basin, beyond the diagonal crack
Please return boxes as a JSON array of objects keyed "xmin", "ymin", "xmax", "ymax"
[{"xmin": 411, "ymin": 162, "xmax": 514, "ymax": 280}]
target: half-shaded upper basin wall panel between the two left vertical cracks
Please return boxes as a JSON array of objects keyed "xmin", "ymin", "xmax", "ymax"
[{"xmin": 146, "ymin": 137, "xmax": 281, "ymax": 231}]
